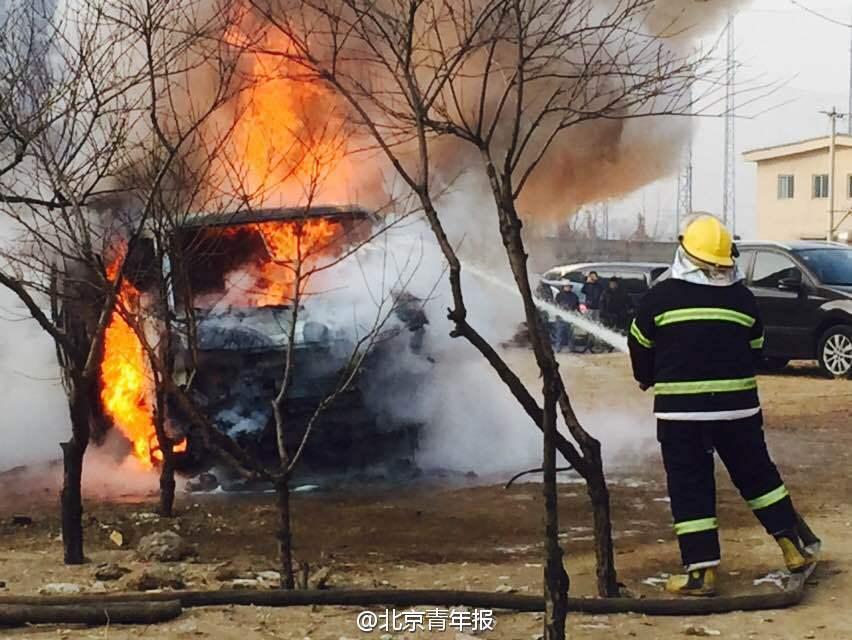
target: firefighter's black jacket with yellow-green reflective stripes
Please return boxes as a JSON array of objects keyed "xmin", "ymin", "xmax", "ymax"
[{"xmin": 628, "ymin": 279, "xmax": 763, "ymax": 421}]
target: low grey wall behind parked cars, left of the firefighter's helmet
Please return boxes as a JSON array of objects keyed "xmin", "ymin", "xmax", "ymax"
[{"xmin": 526, "ymin": 238, "xmax": 677, "ymax": 273}]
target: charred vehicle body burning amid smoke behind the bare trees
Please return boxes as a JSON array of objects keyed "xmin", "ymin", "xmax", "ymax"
[{"xmin": 107, "ymin": 206, "xmax": 428, "ymax": 475}]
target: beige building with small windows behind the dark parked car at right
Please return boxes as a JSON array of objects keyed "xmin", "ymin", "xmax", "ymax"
[{"xmin": 743, "ymin": 135, "xmax": 852, "ymax": 241}]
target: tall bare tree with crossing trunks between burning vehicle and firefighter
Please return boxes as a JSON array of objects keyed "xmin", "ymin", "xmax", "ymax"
[{"xmin": 233, "ymin": 0, "xmax": 724, "ymax": 638}]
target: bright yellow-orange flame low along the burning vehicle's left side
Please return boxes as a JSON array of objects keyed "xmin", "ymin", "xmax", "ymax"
[{"xmin": 100, "ymin": 247, "xmax": 186, "ymax": 469}]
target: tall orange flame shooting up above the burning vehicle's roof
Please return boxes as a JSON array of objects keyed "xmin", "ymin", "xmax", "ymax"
[{"xmin": 225, "ymin": 25, "xmax": 349, "ymax": 205}]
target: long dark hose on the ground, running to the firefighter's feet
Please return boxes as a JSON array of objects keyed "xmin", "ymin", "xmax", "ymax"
[{"xmin": 0, "ymin": 574, "xmax": 807, "ymax": 622}]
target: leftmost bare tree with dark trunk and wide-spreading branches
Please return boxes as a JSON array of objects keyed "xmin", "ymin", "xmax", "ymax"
[{"xmin": 0, "ymin": 0, "xmax": 246, "ymax": 564}]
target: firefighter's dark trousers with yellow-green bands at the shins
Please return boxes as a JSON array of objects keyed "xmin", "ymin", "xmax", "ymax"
[{"xmin": 657, "ymin": 414, "xmax": 796, "ymax": 568}]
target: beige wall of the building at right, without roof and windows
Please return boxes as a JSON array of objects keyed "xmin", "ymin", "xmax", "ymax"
[{"xmin": 756, "ymin": 146, "xmax": 852, "ymax": 240}]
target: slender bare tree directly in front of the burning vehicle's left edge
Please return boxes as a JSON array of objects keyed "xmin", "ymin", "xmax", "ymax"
[{"xmin": 95, "ymin": 0, "xmax": 256, "ymax": 516}]
